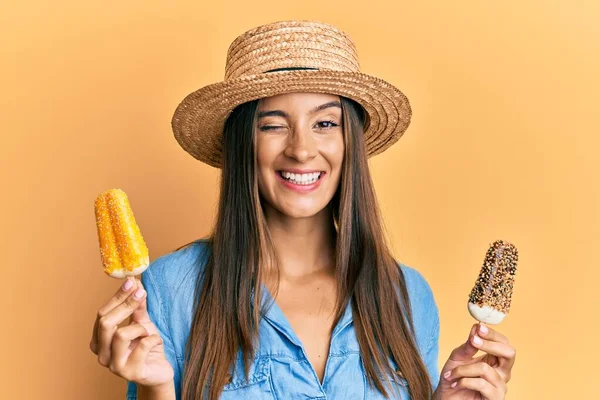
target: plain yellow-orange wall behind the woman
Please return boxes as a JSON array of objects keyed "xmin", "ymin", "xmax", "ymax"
[{"xmin": 0, "ymin": 0, "xmax": 600, "ymax": 400}]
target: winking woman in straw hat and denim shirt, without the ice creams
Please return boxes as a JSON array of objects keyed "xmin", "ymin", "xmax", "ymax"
[{"xmin": 90, "ymin": 21, "xmax": 515, "ymax": 400}]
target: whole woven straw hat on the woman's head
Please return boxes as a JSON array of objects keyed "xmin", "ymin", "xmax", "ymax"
[{"xmin": 171, "ymin": 20, "xmax": 411, "ymax": 168}]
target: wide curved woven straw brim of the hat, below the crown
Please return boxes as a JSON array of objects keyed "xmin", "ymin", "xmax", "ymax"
[{"xmin": 171, "ymin": 70, "xmax": 412, "ymax": 168}]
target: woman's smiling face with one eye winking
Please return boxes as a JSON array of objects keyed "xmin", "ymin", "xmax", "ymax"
[{"xmin": 256, "ymin": 93, "xmax": 344, "ymax": 218}]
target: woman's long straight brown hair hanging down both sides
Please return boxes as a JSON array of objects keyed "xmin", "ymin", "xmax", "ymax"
[{"xmin": 182, "ymin": 97, "xmax": 432, "ymax": 400}]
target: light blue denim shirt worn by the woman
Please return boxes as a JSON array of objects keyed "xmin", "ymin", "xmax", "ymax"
[{"xmin": 127, "ymin": 241, "xmax": 439, "ymax": 400}]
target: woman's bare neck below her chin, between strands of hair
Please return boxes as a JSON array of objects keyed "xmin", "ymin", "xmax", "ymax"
[{"xmin": 265, "ymin": 203, "xmax": 335, "ymax": 280}]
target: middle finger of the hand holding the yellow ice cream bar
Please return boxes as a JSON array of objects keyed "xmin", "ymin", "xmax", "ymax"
[{"xmin": 98, "ymin": 289, "xmax": 146, "ymax": 367}]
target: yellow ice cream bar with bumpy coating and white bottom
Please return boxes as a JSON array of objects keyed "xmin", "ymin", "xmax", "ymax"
[{"xmin": 94, "ymin": 189, "xmax": 149, "ymax": 278}]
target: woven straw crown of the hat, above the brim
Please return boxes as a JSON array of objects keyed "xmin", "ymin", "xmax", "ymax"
[{"xmin": 225, "ymin": 25, "xmax": 360, "ymax": 80}]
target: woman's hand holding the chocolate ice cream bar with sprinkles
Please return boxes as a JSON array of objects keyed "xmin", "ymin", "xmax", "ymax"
[{"xmin": 433, "ymin": 324, "xmax": 516, "ymax": 400}]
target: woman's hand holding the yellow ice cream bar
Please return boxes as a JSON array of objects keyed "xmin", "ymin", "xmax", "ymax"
[{"xmin": 90, "ymin": 277, "xmax": 174, "ymax": 387}]
